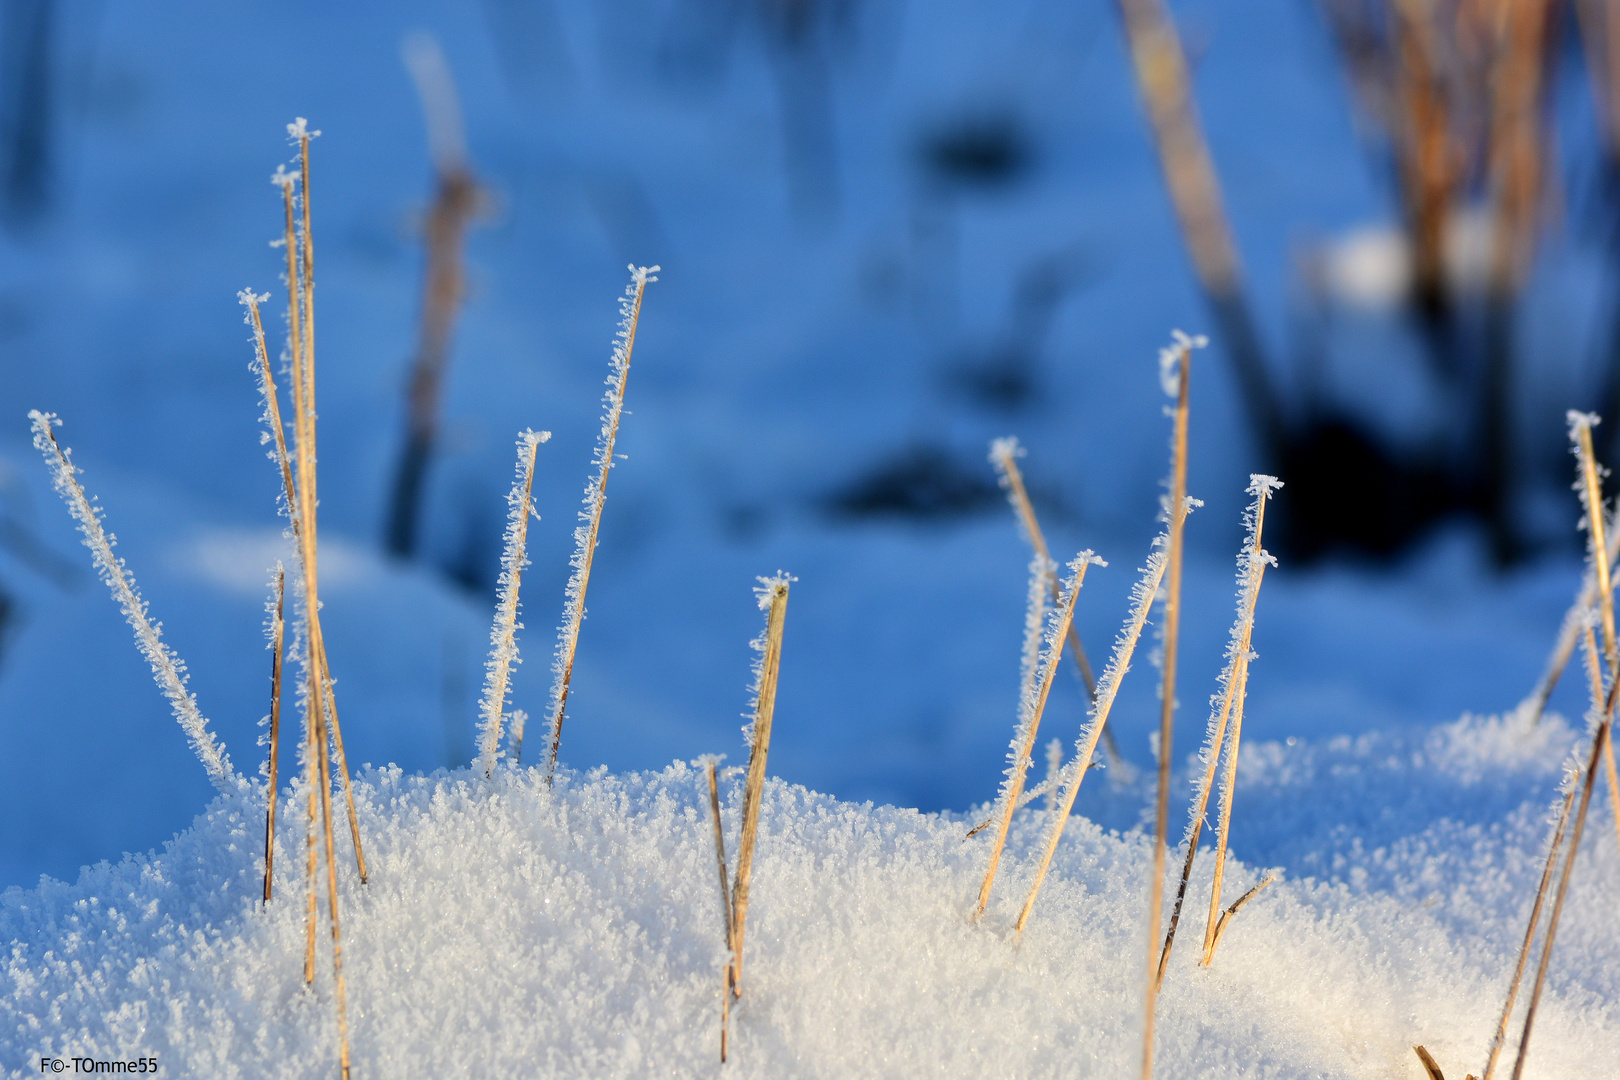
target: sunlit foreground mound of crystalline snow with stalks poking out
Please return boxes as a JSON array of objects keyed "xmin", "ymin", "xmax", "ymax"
[{"xmin": 0, "ymin": 738, "xmax": 1620, "ymax": 1077}]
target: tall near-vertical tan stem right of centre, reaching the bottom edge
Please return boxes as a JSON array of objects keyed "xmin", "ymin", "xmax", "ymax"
[{"xmin": 1142, "ymin": 335, "xmax": 1192, "ymax": 1080}]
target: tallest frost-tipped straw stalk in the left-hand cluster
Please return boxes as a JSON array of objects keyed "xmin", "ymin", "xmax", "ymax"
[{"xmin": 277, "ymin": 137, "xmax": 368, "ymax": 884}]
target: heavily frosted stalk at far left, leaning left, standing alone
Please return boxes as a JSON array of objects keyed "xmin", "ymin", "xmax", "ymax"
[{"xmin": 28, "ymin": 410, "xmax": 241, "ymax": 795}]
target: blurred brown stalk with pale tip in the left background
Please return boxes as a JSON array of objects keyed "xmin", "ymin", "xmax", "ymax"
[{"xmin": 387, "ymin": 34, "xmax": 489, "ymax": 557}]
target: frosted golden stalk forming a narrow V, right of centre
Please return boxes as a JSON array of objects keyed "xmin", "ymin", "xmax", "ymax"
[{"xmin": 974, "ymin": 551, "xmax": 1100, "ymax": 920}]
